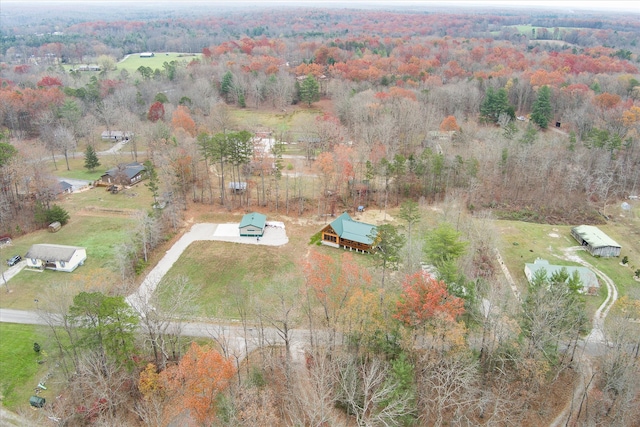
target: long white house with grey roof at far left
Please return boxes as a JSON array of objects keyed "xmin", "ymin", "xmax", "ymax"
[{"xmin": 24, "ymin": 243, "xmax": 87, "ymax": 273}]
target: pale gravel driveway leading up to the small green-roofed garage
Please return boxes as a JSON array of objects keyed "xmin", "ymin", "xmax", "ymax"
[{"xmin": 127, "ymin": 221, "xmax": 289, "ymax": 314}]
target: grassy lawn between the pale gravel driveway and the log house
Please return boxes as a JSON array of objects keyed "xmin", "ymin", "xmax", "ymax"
[{"xmin": 159, "ymin": 241, "xmax": 301, "ymax": 318}]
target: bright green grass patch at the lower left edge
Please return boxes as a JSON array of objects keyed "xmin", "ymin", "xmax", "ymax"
[{"xmin": 0, "ymin": 323, "xmax": 48, "ymax": 410}]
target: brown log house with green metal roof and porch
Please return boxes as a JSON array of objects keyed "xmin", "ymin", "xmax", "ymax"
[{"xmin": 321, "ymin": 212, "xmax": 376, "ymax": 252}]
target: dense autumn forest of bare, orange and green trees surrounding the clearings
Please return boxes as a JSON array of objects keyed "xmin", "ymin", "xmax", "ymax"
[{"xmin": 0, "ymin": 3, "xmax": 640, "ymax": 426}]
